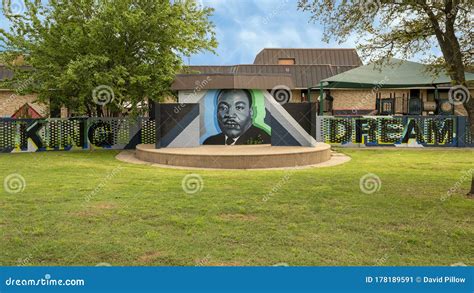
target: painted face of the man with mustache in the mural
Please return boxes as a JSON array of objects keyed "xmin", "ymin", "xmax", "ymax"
[{"xmin": 217, "ymin": 90, "xmax": 253, "ymax": 138}]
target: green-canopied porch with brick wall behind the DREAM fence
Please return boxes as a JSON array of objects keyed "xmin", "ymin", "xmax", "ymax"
[{"xmin": 308, "ymin": 59, "xmax": 474, "ymax": 116}]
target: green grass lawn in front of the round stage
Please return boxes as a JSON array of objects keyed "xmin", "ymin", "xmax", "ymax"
[{"xmin": 0, "ymin": 149, "xmax": 474, "ymax": 266}]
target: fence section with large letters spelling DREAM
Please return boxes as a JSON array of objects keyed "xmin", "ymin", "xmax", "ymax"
[{"xmin": 316, "ymin": 116, "xmax": 474, "ymax": 147}]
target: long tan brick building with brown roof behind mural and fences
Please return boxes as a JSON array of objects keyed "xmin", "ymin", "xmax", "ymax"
[{"xmin": 0, "ymin": 49, "xmax": 474, "ymax": 118}]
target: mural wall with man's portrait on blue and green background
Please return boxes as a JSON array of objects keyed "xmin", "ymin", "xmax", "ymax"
[{"xmin": 174, "ymin": 89, "xmax": 316, "ymax": 146}]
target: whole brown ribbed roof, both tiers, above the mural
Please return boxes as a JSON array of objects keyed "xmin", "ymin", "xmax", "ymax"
[{"xmin": 173, "ymin": 48, "xmax": 362, "ymax": 90}]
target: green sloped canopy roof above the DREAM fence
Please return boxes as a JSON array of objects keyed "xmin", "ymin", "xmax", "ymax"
[{"xmin": 315, "ymin": 59, "xmax": 474, "ymax": 89}]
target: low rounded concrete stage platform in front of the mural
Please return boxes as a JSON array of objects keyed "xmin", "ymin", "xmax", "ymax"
[{"xmin": 135, "ymin": 143, "xmax": 331, "ymax": 169}]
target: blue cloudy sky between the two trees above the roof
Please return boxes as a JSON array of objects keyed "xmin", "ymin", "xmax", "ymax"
[{"xmin": 189, "ymin": 0, "xmax": 355, "ymax": 65}]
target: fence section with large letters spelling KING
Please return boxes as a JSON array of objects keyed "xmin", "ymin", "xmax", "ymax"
[{"xmin": 0, "ymin": 118, "xmax": 156, "ymax": 153}]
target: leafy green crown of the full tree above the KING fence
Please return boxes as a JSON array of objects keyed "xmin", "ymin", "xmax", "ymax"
[{"xmin": 0, "ymin": 0, "xmax": 217, "ymax": 115}]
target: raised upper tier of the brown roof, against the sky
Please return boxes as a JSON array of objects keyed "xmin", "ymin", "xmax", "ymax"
[{"xmin": 253, "ymin": 48, "xmax": 362, "ymax": 66}]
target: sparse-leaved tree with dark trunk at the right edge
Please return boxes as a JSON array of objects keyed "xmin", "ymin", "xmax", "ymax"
[{"xmin": 298, "ymin": 0, "xmax": 474, "ymax": 194}]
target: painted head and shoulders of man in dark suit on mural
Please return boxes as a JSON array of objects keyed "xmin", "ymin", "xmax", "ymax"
[{"xmin": 204, "ymin": 90, "xmax": 271, "ymax": 145}]
